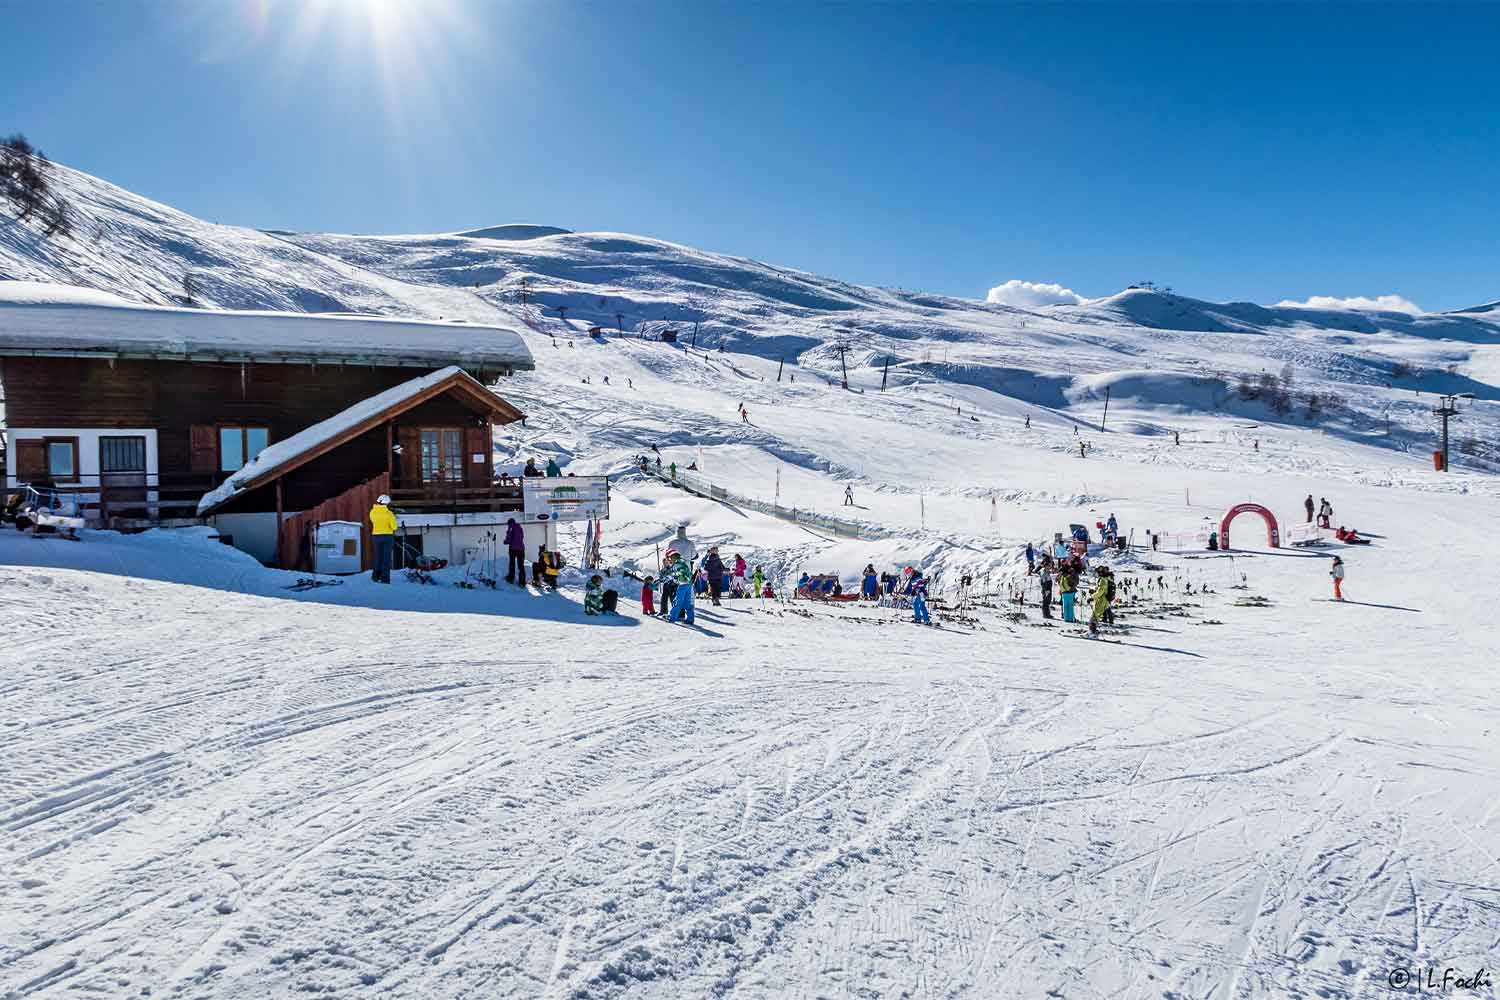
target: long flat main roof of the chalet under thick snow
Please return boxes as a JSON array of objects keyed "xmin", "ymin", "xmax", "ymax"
[{"xmin": 0, "ymin": 280, "xmax": 534, "ymax": 369}]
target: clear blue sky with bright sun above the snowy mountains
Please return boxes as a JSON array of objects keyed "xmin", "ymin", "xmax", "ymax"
[{"xmin": 0, "ymin": 0, "xmax": 1500, "ymax": 309}]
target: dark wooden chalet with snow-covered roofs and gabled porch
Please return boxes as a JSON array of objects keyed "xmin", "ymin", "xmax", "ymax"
[{"xmin": 0, "ymin": 282, "xmax": 543, "ymax": 568}]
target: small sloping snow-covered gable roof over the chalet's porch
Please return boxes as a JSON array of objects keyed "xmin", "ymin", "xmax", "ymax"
[{"xmin": 198, "ymin": 364, "xmax": 521, "ymax": 517}]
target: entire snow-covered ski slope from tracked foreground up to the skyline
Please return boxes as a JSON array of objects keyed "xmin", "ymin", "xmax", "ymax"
[{"xmin": 0, "ymin": 160, "xmax": 1500, "ymax": 1000}]
